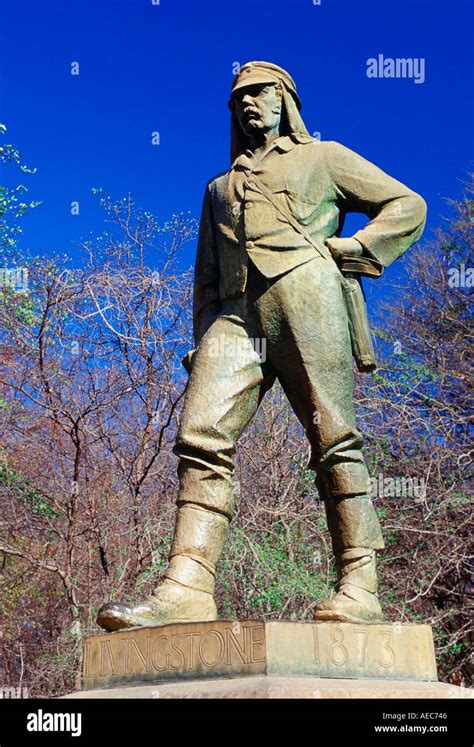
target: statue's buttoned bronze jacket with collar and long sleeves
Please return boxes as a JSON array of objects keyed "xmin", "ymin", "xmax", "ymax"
[{"xmin": 193, "ymin": 134, "xmax": 426, "ymax": 345}]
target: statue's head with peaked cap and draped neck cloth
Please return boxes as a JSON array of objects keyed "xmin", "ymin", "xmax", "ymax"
[{"xmin": 229, "ymin": 62, "xmax": 308, "ymax": 160}]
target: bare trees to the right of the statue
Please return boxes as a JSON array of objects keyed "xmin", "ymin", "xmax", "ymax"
[{"xmin": 358, "ymin": 178, "xmax": 474, "ymax": 684}]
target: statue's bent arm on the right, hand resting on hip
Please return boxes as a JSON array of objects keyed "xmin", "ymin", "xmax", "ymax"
[{"xmin": 321, "ymin": 142, "xmax": 426, "ymax": 267}]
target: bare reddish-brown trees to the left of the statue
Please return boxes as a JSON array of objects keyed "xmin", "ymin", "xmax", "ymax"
[{"xmin": 0, "ymin": 191, "xmax": 196, "ymax": 696}]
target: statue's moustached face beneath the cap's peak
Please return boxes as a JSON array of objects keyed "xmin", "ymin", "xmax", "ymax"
[{"xmin": 232, "ymin": 83, "xmax": 282, "ymax": 138}]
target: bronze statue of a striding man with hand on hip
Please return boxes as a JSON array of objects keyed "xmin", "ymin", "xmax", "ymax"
[{"xmin": 97, "ymin": 62, "xmax": 426, "ymax": 630}]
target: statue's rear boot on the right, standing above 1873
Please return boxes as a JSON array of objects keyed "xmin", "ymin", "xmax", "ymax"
[{"xmin": 314, "ymin": 493, "xmax": 384, "ymax": 622}]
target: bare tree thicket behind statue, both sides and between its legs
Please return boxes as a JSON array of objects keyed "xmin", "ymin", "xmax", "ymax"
[{"xmin": 0, "ymin": 180, "xmax": 472, "ymax": 696}]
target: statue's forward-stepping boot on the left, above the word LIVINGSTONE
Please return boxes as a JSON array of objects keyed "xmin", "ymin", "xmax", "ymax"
[{"xmin": 97, "ymin": 502, "xmax": 229, "ymax": 631}]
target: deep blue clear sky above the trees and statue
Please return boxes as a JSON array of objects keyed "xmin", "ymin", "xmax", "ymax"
[{"xmin": 0, "ymin": 0, "xmax": 473, "ymax": 292}]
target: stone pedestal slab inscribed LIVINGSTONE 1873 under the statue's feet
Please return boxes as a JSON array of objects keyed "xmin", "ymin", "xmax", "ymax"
[{"xmin": 83, "ymin": 620, "xmax": 437, "ymax": 697}]
